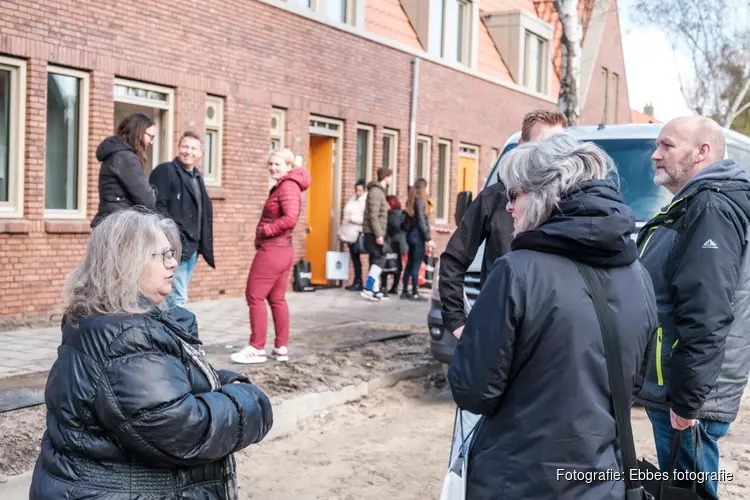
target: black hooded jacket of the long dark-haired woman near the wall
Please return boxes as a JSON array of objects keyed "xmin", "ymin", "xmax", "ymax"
[{"xmin": 91, "ymin": 136, "xmax": 156, "ymax": 227}]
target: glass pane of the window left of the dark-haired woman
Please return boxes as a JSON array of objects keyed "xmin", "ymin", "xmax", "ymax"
[{"xmin": 44, "ymin": 73, "xmax": 80, "ymax": 210}]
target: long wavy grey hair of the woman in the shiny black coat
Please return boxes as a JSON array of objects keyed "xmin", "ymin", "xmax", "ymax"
[{"xmin": 63, "ymin": 209, "xmax": 182, "ymax": 323}]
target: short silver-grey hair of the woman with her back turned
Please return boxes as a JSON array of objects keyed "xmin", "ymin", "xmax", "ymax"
[{"xmin": 500, "ymin": 133, "xmax": 616, "ymax": 234}]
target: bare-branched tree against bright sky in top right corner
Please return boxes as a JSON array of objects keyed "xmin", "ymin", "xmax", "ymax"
[{"xmin": 633, "ymin": 0, "xmax": 750, "ymax": 127}]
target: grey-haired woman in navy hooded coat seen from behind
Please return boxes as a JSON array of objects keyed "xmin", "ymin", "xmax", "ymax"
[{"xmin": 448, "ymin": 134, "xmax": 657, "ymax": 500}]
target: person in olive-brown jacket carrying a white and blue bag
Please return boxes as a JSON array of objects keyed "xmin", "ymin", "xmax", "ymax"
[{"xmin": 360, "ymin": 168, "xmax": 393, "ymax": 301}]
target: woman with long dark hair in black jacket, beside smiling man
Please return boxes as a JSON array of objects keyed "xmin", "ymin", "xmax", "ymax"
[{"xmin": 91, "ymin": 113, "xmax": 156, "ymax": 228}]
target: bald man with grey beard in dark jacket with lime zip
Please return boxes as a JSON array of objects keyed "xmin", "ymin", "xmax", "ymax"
[{"xmin": 637, "ymin": 117, "xmax": 750, "ymax": 495}]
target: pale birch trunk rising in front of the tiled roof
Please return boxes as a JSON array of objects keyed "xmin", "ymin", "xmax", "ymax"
[{"xmin": 555, "ymin": 0, "xmax": 583, "ymax": 126}]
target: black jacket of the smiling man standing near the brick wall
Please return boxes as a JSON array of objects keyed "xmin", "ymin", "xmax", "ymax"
[{"xmin": 150, "ymin": 158, "xmax": 216, "ymax": 267}]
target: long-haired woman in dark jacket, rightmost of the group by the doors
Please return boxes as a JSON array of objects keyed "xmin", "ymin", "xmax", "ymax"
[{"xmin": 401, "ymin": 179, "xmax": 433, "ymax": 300}]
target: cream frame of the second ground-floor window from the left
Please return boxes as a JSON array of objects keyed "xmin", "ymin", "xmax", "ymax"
[{"xmin": 44, "ymin": 66, "xmax": 91, "ymax": 220}]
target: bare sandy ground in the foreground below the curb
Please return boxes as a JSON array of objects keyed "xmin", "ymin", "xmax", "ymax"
[{"xmin": 238, "ymin": 376, "xmax": 750, "ymax": 500}]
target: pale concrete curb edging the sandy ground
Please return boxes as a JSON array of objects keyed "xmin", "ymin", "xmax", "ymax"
[{"xmin": 0, "ymin": 363, "xmax": 442, "ymax": 500}]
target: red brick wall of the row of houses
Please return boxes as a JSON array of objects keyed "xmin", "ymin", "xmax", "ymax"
[{"xmin": 0, "ymin": 0, "xmax": 627, "ymax": 316}]
